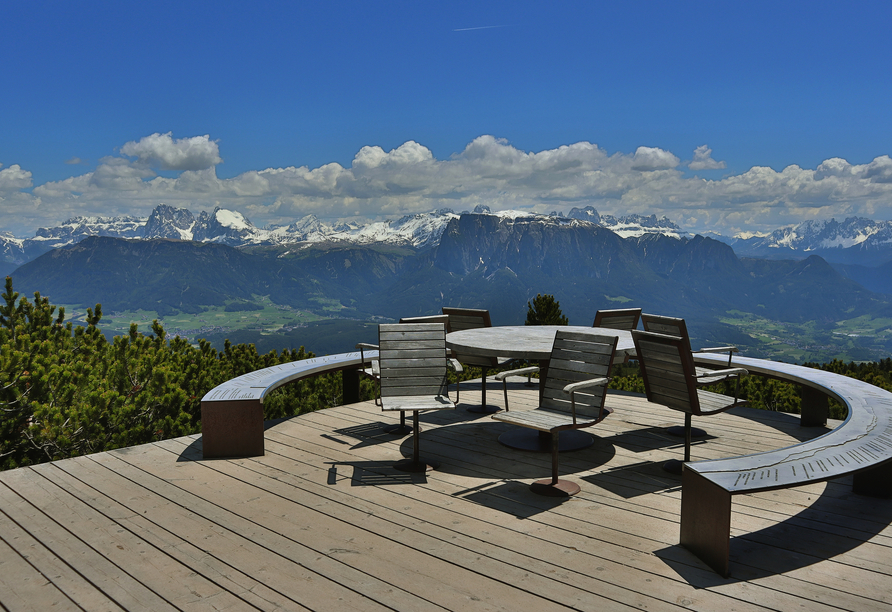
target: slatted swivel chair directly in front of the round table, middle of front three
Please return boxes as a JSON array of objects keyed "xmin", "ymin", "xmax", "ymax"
[{"xmin": 492, "ymin": 330, "xmax": 618, "ymax": 497}]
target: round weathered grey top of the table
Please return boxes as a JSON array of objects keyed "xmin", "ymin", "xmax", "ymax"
[{"xmin": 446, "ymin": 325, "xmax": 635, "ymax": 360}]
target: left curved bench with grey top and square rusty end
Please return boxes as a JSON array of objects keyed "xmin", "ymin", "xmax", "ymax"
[{"xmin": 201, "ymin": 351, "xmax": 378, "ymax": 459}]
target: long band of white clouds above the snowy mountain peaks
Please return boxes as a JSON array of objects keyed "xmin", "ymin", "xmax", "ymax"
[{"xmin": 0, "ymin": 134, "xmax": 892, "ymax": 235}]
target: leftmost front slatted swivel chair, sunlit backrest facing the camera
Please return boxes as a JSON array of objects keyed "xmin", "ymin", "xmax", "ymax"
[{"xmin": 378, "ymin": 323, "xmax": 455, "ymax": 472}]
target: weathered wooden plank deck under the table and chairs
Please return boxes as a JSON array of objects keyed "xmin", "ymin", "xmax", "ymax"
[{"xmin": 0, "ymin": 384, "xmax": 892, "ymax": 612}]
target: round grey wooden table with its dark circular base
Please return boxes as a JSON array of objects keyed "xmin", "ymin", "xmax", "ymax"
[{"xmin": 446, "ymin": 325, "xmax": 635, "ymax": 453}]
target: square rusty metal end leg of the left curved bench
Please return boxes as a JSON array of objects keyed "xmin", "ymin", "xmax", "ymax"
[{"xmin": 201, "ymin": 400, "xmax": 263, "ymax": 459}]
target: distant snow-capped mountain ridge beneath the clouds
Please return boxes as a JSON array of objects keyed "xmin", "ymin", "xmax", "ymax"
[{"xmin": 0, "ymin": 204, "xmax": 892, "ymax": 268}]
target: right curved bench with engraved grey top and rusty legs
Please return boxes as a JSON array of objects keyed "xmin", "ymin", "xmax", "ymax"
[{"xmin": 681, "ymin": 354, "xmax": 892, "ymax": 576}]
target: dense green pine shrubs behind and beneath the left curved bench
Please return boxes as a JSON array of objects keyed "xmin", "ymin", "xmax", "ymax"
[{"xmin": 0, "ymin": 277, "xmax": 370, "ymax": 469}]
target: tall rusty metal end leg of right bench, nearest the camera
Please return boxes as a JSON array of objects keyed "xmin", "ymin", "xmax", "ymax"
[{"xmin": 680, "ymin": 469, "xmax": 731, "ymax": 577}]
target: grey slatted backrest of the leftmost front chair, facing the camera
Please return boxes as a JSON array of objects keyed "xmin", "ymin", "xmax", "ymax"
[{"xmin": 378, "ymin": 323, "xmax": 448, "ymax": 398}]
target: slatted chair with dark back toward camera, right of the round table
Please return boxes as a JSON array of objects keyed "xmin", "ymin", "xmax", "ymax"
[{"xmin": 632, "ymin": 330, "xmax": 747, "ymax": 474}]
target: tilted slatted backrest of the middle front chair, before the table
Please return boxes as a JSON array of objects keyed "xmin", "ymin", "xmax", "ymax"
[{"xmin": 539, "ymin": 330, "xmax": 618, "ymax": 417}]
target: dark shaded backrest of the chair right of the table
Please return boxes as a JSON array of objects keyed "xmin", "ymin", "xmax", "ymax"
[{"xmin": 632, "ymin": 330, "xmax": 703, "ymax": 414}]
